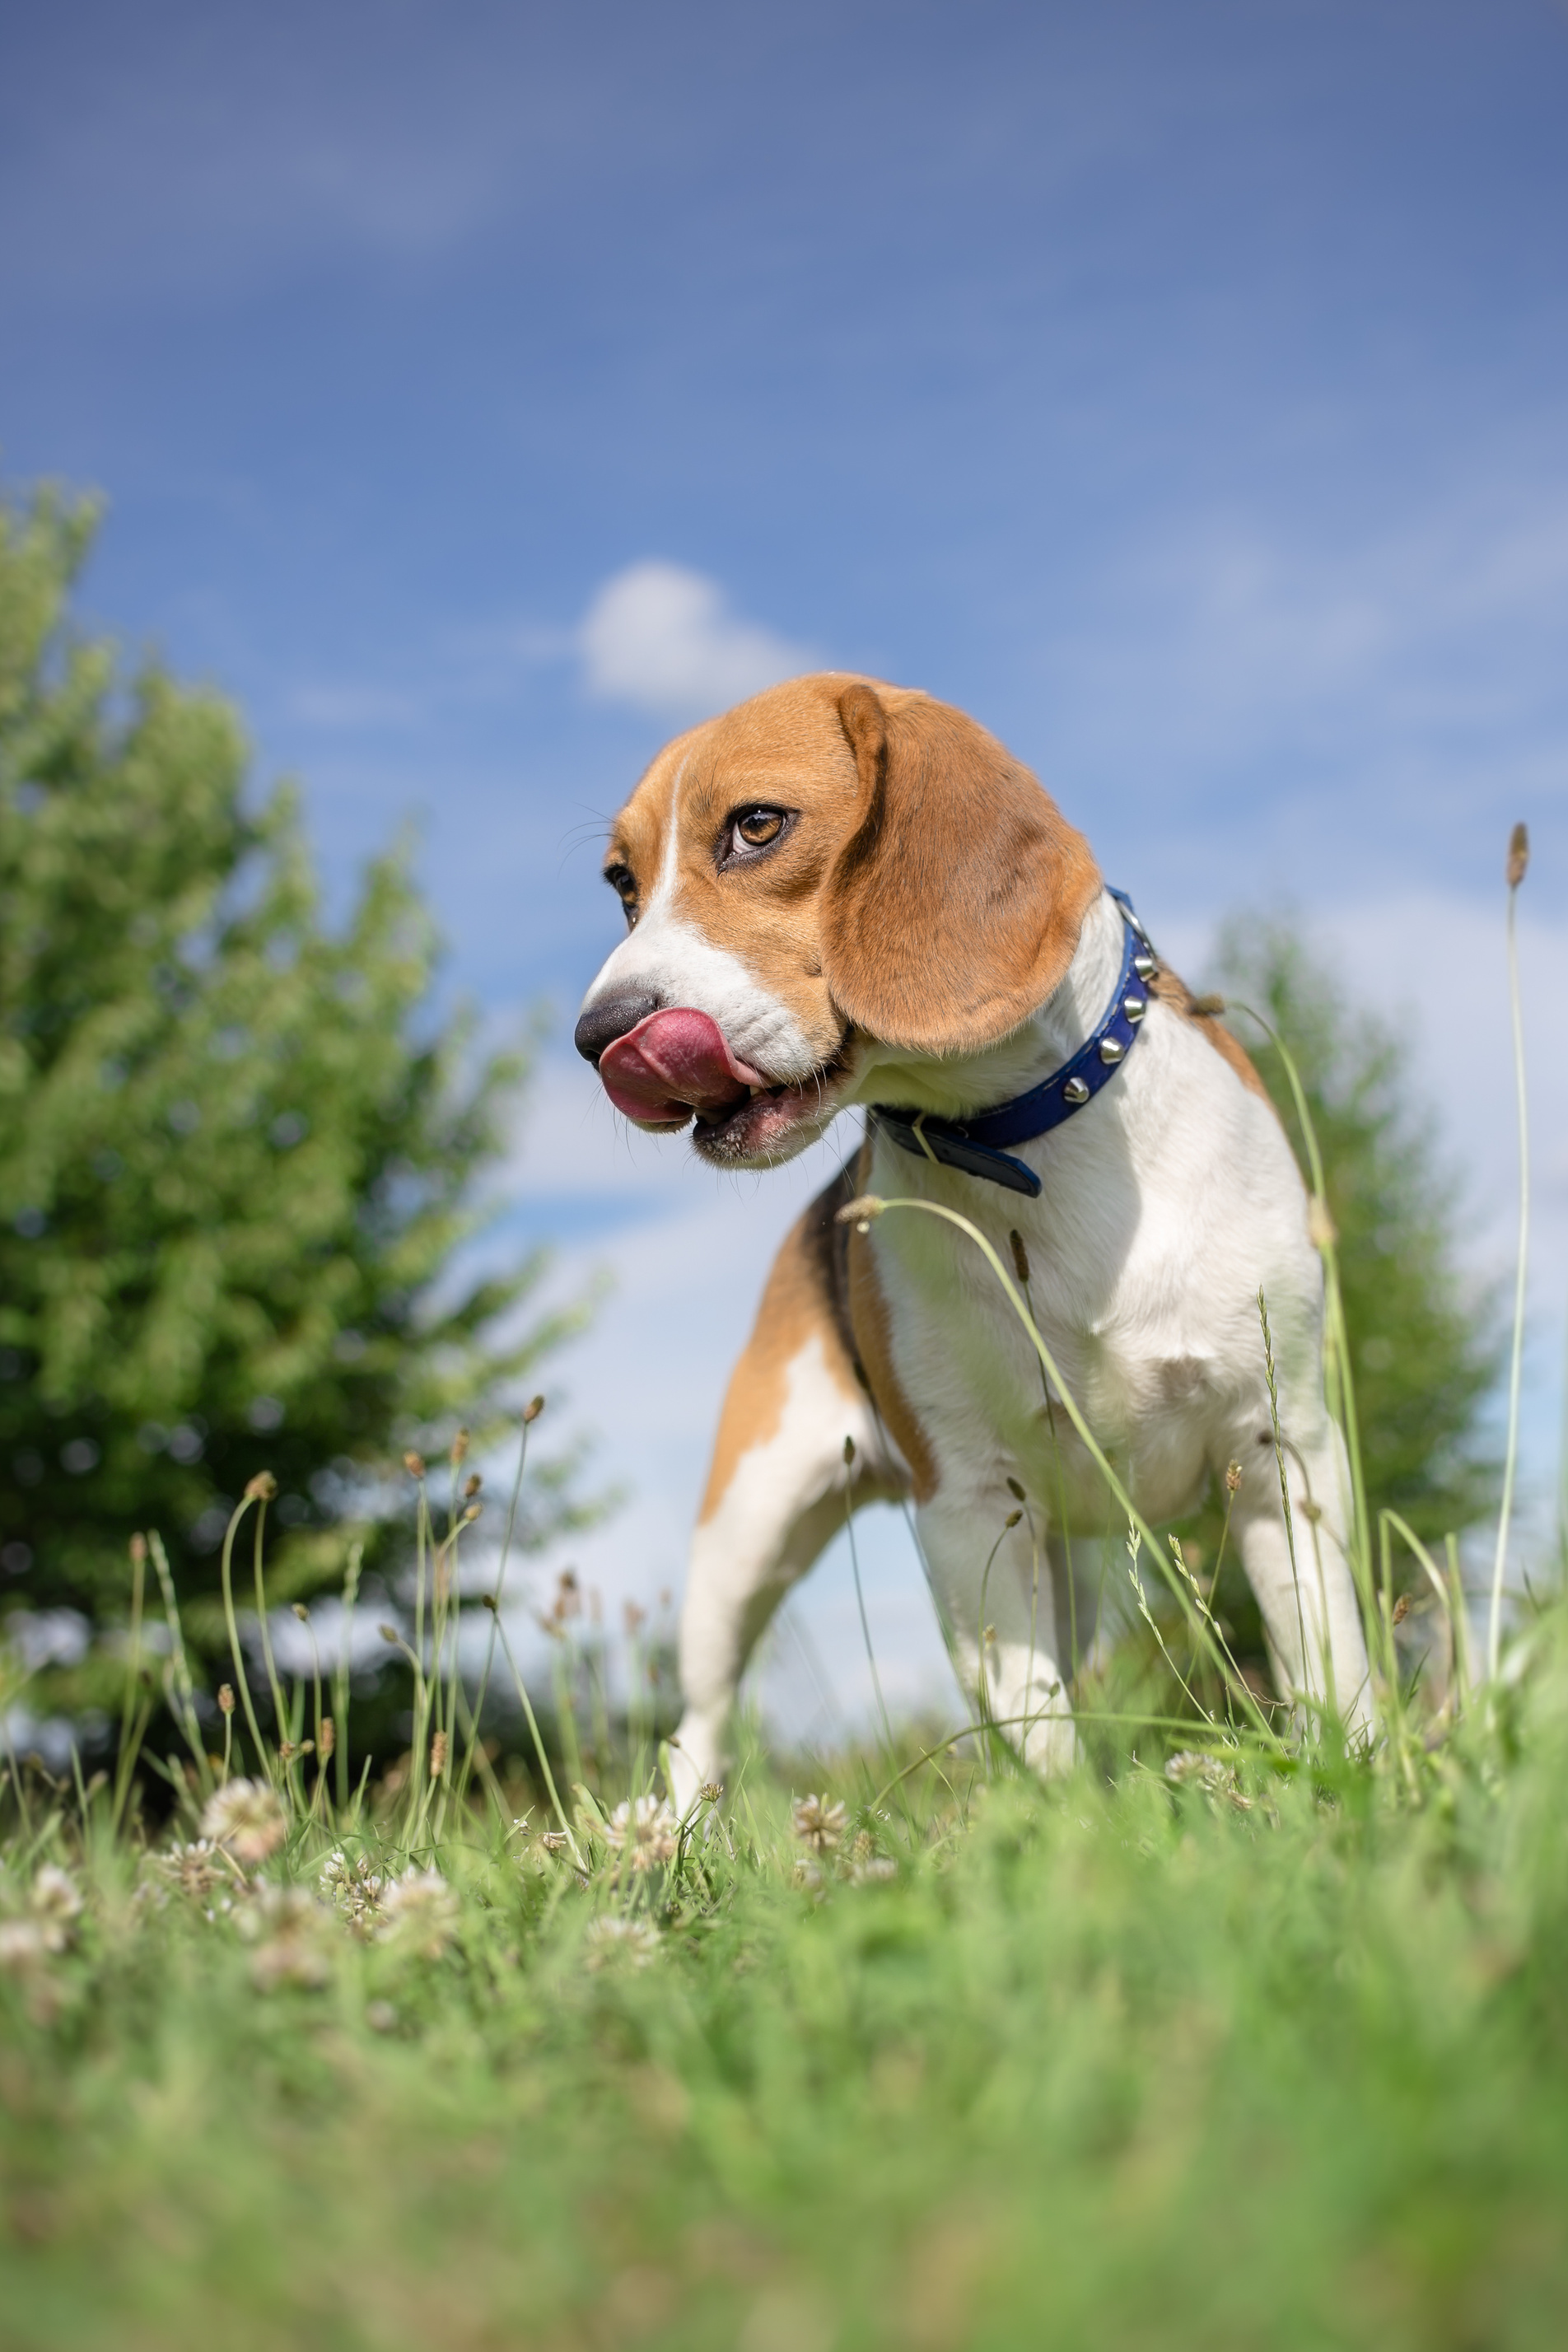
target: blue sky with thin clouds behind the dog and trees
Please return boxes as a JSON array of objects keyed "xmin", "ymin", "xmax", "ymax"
[{"xmin": 0, "ymin": 0, "xmax": 1568, "ymax": 1731}]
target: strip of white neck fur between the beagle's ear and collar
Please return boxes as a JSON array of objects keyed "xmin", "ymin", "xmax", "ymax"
[{"xmin": 849, "ymin": 891, "xmax": 1126, "ymax": 1119}]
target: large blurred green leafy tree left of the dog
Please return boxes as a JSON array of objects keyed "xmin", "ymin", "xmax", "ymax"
[{"xmin": 0, "ymin": 492, "xmax": 582, "ymax": 1646}]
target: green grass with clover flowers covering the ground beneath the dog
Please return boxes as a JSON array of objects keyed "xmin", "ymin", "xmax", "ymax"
[{"xmin": 0, "ymin": 1618, "xmax": 1568, "ymax": 2352}]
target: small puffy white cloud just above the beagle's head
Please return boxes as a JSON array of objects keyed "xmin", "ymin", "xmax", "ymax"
[{"xmin": 578, "ymin": 562, "xmax": 814, "ymax": 717}]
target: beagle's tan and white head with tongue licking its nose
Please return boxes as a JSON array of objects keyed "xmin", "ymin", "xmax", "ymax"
[{"xmin": 576, "ymin": 673, "xmax": 1100, "ymax": 1167}]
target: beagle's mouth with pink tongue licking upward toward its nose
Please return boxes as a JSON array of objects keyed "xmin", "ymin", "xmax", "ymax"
[{"xmin": 600, "ymin": 1006, "xmax": 842, "ymax": 1162}]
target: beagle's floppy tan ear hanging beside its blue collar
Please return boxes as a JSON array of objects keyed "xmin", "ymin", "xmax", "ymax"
[{"xmin": 823, "ymin": 684, "xmax": 1100, "ymax": 1053}]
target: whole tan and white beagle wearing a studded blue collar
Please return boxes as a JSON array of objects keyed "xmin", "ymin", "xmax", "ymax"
[{"xmin": 576, "ymin": 673, "xmax": 1370, "ymax": 1802}]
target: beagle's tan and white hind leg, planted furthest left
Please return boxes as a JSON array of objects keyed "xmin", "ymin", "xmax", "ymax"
[{"xmin": 670, "ymin": 1171, "xmax": 905, "ymax": 1808}]
